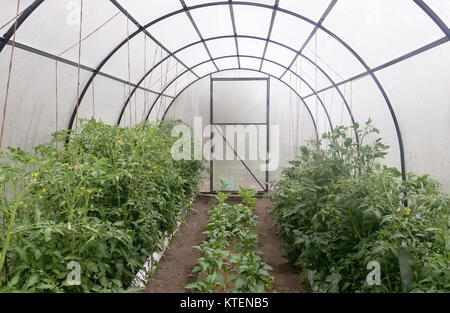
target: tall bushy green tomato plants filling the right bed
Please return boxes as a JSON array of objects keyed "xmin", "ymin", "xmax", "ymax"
[{"xmin": 270, "ymin": 121, "xmax": 450, "ymax": 292}]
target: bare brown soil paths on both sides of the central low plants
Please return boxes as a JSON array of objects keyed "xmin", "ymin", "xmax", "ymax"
[{"xmin": 145, "ymin": 197, "xmax": 307, "ymax": 293}]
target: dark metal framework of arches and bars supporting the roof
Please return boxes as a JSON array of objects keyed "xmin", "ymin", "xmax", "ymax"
[{"xmin": 0, "ymin": 0, "xmax": 450, "ymax": 185}]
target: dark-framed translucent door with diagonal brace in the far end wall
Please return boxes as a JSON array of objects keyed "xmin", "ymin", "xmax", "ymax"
[{"xmin": 209, "ymin": 77, "xmax": 270, "ymax": 193}]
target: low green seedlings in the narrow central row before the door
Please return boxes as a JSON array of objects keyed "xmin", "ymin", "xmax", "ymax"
[{"xmin": 186, "ymin": 188, "xmax": 273, "ymax": 293}]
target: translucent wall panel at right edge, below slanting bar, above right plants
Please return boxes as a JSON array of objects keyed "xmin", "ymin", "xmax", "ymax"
[{"xmin": 377, "ymin": 43, "xmax": 450, "ymax": 190}]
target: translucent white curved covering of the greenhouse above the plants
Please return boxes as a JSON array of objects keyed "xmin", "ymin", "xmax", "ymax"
[{"xmin": 0, "ymin": 0, "xmax": 450, "ymax": 189}]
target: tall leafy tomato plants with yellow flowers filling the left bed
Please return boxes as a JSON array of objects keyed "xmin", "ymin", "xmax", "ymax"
[{"xmin": 0, "ymin": 120, "xmax": 203, "ymax": 292}]
